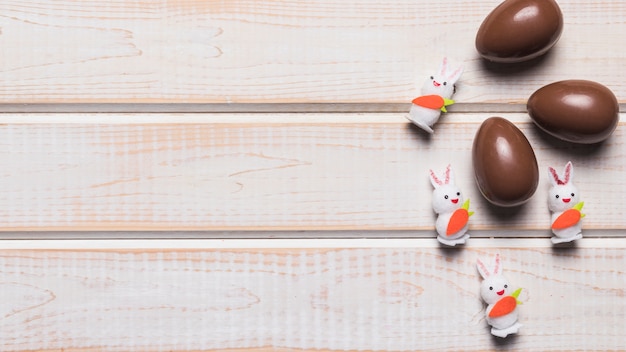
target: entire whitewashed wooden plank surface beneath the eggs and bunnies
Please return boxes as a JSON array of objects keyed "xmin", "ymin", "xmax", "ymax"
[{"xmin": 0, "ymin": 0, "xmax": 626, "ymax": 352}]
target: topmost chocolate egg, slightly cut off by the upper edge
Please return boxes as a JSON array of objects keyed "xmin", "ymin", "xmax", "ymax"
[{"xmin": 476, "ymin": 0, "xmax": 563, "ymax": 63}]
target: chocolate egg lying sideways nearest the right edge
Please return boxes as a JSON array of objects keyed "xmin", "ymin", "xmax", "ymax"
[{"xmin": 526, "ymin": 80, "xmax": 619, "ymax": 144}]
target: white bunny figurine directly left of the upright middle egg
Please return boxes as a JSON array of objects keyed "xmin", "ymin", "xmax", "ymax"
[{"xmin": 430, "ymin": 165, "xmax": 474, "ymax": 246}]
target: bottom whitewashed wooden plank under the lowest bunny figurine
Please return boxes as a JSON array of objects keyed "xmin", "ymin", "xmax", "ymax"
[{"xmin": 0, "ymin": 239, "xmax": 626, "ymax": 351}]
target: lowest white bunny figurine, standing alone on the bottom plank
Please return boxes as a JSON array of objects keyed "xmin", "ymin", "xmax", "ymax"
[{"xmin": 476, "ymin": 254, "xmax": 522, "ymax": 338}]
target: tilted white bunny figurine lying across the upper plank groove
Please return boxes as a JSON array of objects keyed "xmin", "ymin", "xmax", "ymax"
[{"xmin": 407, "ymin": 58, "xmax": 463, "ymax": 133}]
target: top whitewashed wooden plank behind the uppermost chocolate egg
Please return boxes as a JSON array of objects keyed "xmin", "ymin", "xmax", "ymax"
[{"xmin": 0, "ymin": 0, "xmax": 626, "ymax": 106}]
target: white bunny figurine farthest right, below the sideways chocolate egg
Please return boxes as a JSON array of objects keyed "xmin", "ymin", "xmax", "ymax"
[{"xmin": 548, "ymin": 161, "xmax": 585, "ymax": 244}]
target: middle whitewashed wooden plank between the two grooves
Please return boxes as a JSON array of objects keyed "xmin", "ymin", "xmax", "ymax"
[{"xmin": 0, "ymin": 113, "xmax": 626, "ymax": 236}]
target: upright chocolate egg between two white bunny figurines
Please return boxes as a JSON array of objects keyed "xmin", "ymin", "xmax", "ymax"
[{"xmin": 472, "ymin": 117, "xmax": 539, "ymax": 207}]
